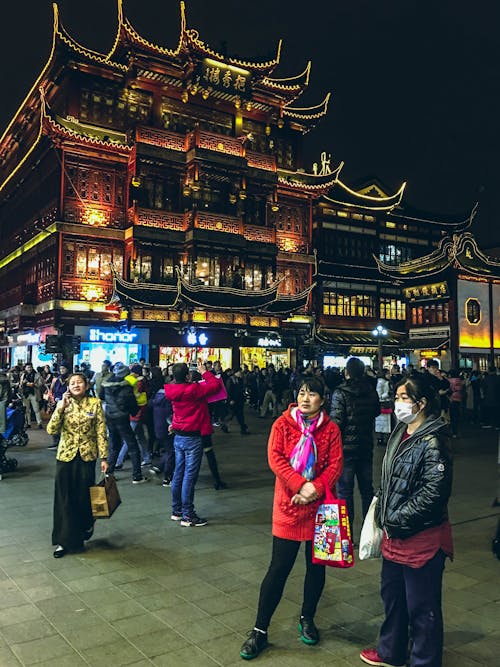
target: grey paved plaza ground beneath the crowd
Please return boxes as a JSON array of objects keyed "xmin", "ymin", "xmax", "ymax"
[{"xmin": 0, "ymin": 415, "xmax": 500, "ymax": 667}]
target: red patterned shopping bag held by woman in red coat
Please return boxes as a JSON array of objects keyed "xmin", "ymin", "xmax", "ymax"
[{"xmin": 312, "ymin": 484, "xmax": 354, "ymax": 567}]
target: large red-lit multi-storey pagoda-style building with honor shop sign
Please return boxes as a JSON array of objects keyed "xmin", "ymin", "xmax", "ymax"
[{"xmin": 0, "ymin": 0, "xmax": 344, "ymax": 367}]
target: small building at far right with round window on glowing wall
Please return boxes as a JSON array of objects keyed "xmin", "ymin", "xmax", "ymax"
[{"xmin": 377, "ymin": 225, "xmax": 500, "ymax": 370}]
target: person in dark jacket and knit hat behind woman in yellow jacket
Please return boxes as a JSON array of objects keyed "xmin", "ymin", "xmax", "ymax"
[{"xmin": 99, "ymin": 361, "xmax": 147, "ymax": 484}]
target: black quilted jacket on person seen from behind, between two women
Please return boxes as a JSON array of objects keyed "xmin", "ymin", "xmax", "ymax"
[{"xmin": 330, "ymin": 378, "xmax": 380, "ymax": 458}]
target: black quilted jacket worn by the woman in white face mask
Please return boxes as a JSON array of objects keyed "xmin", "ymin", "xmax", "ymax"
[{"xmin": 375, "ymin": 417, "xmax": 453, "ymax": 538}]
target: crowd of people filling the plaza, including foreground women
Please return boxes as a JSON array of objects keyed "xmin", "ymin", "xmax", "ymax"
[{"xmin": 0, "ymin": 357, "xmax": 500, "ymax": 667}]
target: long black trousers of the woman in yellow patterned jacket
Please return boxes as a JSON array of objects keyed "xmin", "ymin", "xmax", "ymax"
[{"xmin": 52, "ymin": 454, "xmax": 95, "ymax": 550}]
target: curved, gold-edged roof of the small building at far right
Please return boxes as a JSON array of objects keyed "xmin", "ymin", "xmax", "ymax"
[{"xmin": 374, "ymin": 232, "xmax": 500, "ymax": 281}]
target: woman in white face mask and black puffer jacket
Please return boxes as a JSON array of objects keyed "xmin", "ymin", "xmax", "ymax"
[{"xmin": 360, "ymin": 374, "xmax": 453, "ymax": 667}]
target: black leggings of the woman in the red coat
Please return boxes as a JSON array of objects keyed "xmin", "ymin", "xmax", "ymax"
[{"xmin": 255, "ymin": 537, "xmax": 325, "ymax": 630}]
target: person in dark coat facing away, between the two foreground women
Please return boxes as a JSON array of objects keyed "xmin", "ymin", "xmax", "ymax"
[{"xmin": 330, "ymin": 357, "xmax": 380, "ymax": 534}]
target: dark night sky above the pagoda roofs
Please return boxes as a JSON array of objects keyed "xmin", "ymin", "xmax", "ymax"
[{"xmin": 0, "ymin": 0, "xmax": 500, "ymax": 244}]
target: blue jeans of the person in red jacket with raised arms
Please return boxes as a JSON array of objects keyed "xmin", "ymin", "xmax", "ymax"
[{"xmin": 171, "ymin": 435, "xmax": 203, "ymax": 518}]
